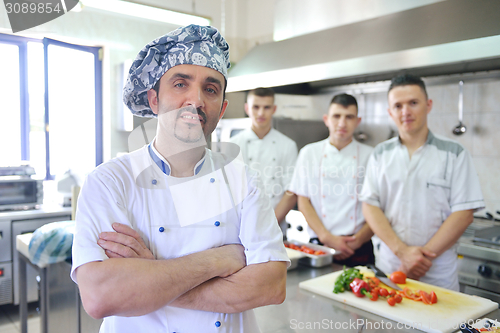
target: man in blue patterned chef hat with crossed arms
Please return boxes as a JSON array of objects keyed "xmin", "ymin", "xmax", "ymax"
[{"xmin": 71, "ymin": 25, "xmax": 289, "ymax": 333}]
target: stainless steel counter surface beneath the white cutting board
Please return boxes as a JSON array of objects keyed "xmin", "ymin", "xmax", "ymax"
[{"xmin": 255, "ymin": 264, "xmax": 500, "ymax": 333}]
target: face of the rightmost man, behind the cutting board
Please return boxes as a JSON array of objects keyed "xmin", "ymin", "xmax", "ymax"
[{"xmin": 388, "ymin": 85, "xmax": 432, "ymax": 136}]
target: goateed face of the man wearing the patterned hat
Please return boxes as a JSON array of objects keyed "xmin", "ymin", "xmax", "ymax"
[{"xmin": 148, "ymin": 65, "xmax": 227, "ymax": 143}]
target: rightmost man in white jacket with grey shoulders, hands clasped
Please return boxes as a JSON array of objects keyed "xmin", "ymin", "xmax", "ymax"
[{"xmin": 361, "ymin": 74, "xmax": 484, "ymax": 290}]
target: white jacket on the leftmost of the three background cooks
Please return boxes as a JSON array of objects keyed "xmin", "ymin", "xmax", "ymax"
[{"xmin": 230, "ymin": 128, "xmax": 297, "ymax": 208}]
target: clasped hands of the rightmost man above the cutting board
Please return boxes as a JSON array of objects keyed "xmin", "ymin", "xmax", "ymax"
[{"xmin": 396, "ymin": 246, "xmax": 436, "ymax": 280}]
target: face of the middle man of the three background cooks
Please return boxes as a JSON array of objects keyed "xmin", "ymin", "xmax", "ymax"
[{"xmin": 323, "ymin": 103, "xmax": 361, "ymax": 149}]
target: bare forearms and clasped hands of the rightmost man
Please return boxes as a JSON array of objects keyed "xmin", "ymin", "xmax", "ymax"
[{"xmin": 363, "ymin": 202, "xmax": 473, "ymax": 279}]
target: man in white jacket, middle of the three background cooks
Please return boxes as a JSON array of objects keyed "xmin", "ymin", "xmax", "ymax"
[{"xmin": 290, "ymin": 94, "xmax": 374, "ymax": 267}]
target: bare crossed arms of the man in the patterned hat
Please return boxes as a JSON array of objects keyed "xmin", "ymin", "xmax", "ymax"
[{"xmin": 76, "ymin": 223, "xmax": 286, "ymax": 318}]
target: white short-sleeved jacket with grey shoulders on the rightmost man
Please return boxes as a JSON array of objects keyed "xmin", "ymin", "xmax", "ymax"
[{"xmin": 361, "ymin": 131, "xmax": 484, "ymax": 290}]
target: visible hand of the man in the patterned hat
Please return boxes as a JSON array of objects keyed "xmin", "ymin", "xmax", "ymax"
[{"xmin": 97, "ymin": 223, "xmax": 155, "ymax": 259}]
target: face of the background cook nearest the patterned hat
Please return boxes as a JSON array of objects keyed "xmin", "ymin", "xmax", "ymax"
[{"xmin": 245, "ymin": 94, "xmax": 276, "ymax": 131}]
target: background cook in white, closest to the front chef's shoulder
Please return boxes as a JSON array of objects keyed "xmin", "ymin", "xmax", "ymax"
[{"xmin": 230, "ymin": 88, "xmax": 297, "ymax": 230}]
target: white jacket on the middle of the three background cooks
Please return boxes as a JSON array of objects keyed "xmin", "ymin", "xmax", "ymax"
[{"xmin": 290, "ymin": 138, "xmax": 373, "ymax": 238}]
